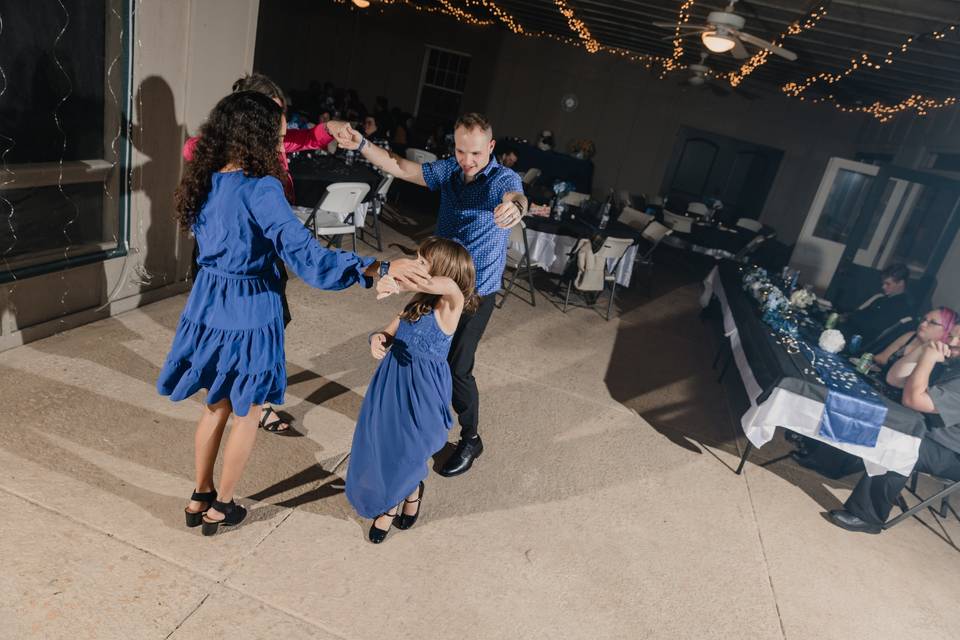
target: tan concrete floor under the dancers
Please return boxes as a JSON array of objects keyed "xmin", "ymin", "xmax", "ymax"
[{"xmin": 0, "ymin": 222, "xmax": 960, "ymax": 640}]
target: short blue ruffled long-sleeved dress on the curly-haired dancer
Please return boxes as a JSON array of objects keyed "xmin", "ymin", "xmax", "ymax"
[{"xmin": 157, "ymin": 171, "xmax": 374, "ymax": 416}]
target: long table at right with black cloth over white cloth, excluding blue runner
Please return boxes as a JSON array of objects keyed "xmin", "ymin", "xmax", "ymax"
[{"xmin": 700, "ymin": 260, "xmax": 926, "ymax": 476}]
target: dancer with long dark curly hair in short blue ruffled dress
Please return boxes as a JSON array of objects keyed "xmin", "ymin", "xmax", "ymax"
[{"xmin": 157, "ymin": 91, "xmax": 429, "ymax": 535}]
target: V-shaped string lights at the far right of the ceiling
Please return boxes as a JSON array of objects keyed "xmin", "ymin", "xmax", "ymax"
[{"xmin": 780, "ymin": 24, "xmax": 958, "ymax": 123}]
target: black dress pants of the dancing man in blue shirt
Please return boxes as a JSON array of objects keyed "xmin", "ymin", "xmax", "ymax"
[{"xmin": 447, "ymin": 293, "xmax": 497, "ymax": 438}]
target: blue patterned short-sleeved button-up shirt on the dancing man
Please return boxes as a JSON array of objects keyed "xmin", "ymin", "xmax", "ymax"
[{"xmin": 423, "ymin": 157, "xmax": 523, "ymax": 296}]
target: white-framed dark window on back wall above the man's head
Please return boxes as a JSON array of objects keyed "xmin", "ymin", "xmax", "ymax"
[{"xmin": 416, "ymin": 46, "xmax": 470, "ymax": 131}]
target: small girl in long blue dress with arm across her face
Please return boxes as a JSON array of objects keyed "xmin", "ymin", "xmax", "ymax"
[{"xmin": 346, "ymin": 238, "xmax": 478, "ymax": 543}]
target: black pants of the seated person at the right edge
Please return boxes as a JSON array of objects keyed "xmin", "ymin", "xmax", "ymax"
[{"xmin": 843, "ymin": 438, "xmax": 960, "ymax": 525}]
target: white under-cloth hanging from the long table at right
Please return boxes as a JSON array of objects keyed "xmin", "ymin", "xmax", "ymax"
[{"xmin": 700, "ymin": 267, "xmax": 920, "ymax": 476}]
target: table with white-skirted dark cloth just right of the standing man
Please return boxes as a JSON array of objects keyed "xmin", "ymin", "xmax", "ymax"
[{"xmin": 511, "ymin": 216, "xmax": 640, "ymax": 287}]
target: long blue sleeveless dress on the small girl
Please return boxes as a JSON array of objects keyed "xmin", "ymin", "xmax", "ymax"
[{"xmin": 346, "ymin": 313, "xmax": 453, "ymax": 518}]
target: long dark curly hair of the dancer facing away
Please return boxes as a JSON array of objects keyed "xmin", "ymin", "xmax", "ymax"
[{"xmin": 175, "ymin": 91, "xmax": 286, "ymax": 229}]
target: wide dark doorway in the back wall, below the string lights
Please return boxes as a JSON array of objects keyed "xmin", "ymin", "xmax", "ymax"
[{"xmin": 661, "ymin": 127, "xmax": 783, "ymax": 219}]
